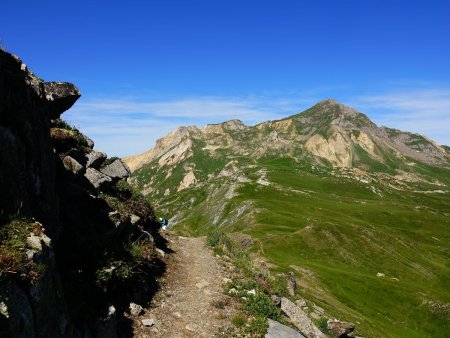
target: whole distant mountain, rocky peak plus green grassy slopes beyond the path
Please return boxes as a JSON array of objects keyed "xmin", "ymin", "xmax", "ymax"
[{"xmin": 125, "ymin": 100, "xmax": 450, "ymax": 337}]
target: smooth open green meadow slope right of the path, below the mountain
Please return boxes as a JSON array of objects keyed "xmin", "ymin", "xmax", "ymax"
[{"xmin": 239, "ymin": 159, "xmax": 450, "ymax": 337}]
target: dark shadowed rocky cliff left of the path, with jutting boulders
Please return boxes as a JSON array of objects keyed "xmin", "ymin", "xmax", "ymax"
[{"xmin": 0, "ymin": 50, "xmax": 162, "ymax": 337}]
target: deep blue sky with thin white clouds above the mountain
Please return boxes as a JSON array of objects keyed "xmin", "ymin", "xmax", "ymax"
[{"xmin": 0, "ymin": 0, "xmax": 450, "ymax": 156}]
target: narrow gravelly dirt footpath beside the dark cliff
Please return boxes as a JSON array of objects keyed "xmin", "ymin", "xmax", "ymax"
[{"xmin": 134, "ymin": 237, "xmax": 235, "ymax": 338}]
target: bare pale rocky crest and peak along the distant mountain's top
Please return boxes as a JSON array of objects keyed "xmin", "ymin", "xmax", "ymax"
[{"xmin": 124, "ymin": 99, "xmax": 450, "ymax": 171}]
